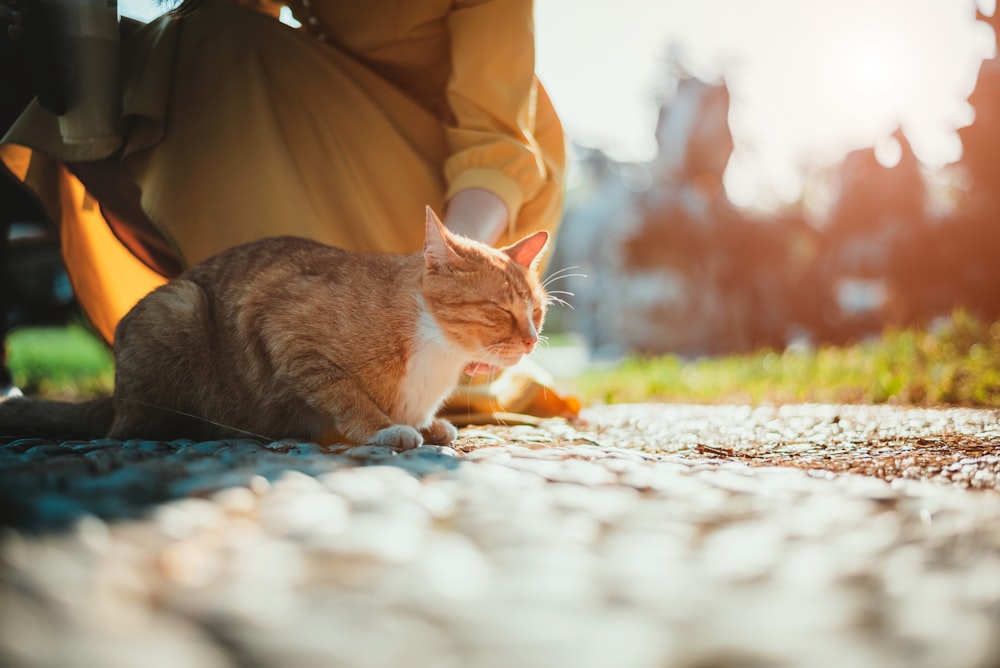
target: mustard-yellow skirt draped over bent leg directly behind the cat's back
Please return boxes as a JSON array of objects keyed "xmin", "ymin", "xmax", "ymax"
[{"xmin": 125, "ymin": 3, "xmax": 446, "ymax": 264}]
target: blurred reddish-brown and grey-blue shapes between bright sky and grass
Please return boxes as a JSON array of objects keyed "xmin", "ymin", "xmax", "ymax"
[{"xmin": 551, "ymin": 6, "xmax": 1000, "ymax": 355}]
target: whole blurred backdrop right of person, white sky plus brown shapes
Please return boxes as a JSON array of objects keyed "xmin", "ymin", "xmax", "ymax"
[{"xmin": 538, "ymin": 0, "xmax": 1000, "ymax": 357}]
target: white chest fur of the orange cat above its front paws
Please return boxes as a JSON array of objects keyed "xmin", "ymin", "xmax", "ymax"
[{"xmin": 390, "ymin": 304, "xmax": 471, "ymax": 428}]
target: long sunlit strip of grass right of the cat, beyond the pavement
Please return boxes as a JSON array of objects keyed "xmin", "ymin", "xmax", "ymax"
[{"xmin": 574, "ymin": 312, "xmax": 1000, "ymax": 407}]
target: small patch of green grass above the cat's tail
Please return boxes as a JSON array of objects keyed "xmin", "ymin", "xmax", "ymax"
[{"xmin": 7, "ymin": 324, "xmax": 114, "ymax": 399}]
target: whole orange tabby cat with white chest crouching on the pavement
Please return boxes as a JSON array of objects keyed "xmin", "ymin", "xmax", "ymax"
[{"xmin": 0, "ymin": 208, "xmax": 548, "ymax": 449}]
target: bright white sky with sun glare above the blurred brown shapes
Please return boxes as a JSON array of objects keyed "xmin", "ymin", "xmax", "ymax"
[{"xmin": 121, "ymin": 0, "xmax": 994, "ymax": 206}]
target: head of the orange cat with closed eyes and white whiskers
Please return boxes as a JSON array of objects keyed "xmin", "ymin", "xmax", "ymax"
[{"xmin": 423, "ymin": 207, "xmax": 549, "ymax": 370}]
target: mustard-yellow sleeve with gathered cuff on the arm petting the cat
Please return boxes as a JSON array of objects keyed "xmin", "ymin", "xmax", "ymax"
[{"xmin": 444, "ymin": 0, "xmax": 548, "ymax": 221}]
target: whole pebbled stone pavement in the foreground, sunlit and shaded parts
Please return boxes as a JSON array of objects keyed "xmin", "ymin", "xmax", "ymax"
[{"xmin": 0, "ymin": 405, "xmax": 1000, "ymax": 668}]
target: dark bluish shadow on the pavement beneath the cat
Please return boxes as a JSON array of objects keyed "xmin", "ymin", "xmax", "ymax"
[{"xmin": 0, "ymin": 439, "xmax": 458, "ymax": 531}]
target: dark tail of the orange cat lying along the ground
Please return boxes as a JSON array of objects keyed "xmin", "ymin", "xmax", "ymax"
[{"xmin": 0, "ymin": 397, "xmax": 114, "ymax": 440}]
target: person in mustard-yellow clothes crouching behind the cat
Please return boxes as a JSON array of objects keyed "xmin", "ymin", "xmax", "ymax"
[{"xmin": 0, "ymin": 0, "xmax": 565, "ymax": 420}]
